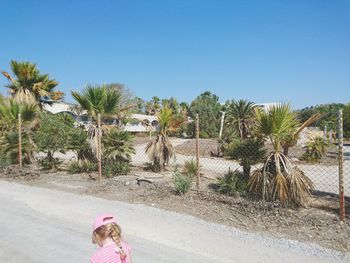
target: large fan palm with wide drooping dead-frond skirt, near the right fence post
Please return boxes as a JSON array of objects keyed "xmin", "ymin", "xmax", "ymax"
[{"xmin": 249, "ymin": 104, "xmax": 313, "ymax": 206}]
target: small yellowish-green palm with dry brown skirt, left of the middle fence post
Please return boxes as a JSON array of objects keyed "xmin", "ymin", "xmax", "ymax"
[{"xmin": 146, "ymin": 104, "xmax": 183, "ymax": 172}]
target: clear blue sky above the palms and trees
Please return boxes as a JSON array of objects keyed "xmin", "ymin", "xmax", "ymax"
[{"xmin": 0, "ymin": 0, "xmax": 350, "ymax": 108}]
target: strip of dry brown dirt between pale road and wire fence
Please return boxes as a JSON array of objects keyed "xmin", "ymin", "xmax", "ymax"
[{"xmin": 0, "ymin": 166, "xmax": 350, "ymax": 255}]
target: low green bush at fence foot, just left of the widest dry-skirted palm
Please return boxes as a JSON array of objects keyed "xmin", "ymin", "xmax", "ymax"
[{"xmin": 216, "ymin": 170, "xmax": 247, "ymax": 196}]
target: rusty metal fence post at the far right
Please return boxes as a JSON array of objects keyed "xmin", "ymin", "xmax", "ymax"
[{"xmin": 338, "ymin": 110, "xmax": 345, "ymax": 221}]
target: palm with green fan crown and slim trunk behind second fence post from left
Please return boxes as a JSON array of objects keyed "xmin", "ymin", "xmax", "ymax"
[{"xmin": 72, "ymin": 85, "xmax": 121, "ymax": 181}]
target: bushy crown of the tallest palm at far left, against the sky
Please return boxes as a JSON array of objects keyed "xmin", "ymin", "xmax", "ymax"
[{"xmin": 2, "ymin": 60, "xmax": 58, "ymax": 107}]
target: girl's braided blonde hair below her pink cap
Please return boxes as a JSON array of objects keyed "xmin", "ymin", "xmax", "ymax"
[{"xmin": 92, "ymin": 223, "xmax": 122, "ymax": 247}]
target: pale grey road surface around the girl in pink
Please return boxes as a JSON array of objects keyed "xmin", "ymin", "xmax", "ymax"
[{"xmin": 0, "ymin": 180, "xmax": 350, "ymax": 263}]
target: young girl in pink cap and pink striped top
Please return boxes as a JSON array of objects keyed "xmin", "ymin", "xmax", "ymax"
[{"xmin": 90, "ymin": 214, "xmax": 132, "ymax": 263}]
